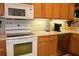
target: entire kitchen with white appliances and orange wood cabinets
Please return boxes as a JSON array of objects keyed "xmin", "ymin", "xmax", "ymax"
[{"xmin": 0, "ymin": 3, "xmax": 79, "ymax": 56}]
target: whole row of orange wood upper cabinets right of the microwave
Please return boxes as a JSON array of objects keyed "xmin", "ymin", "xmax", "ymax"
[{"xmin": 34, "ymin": 3, "xmax": 74, "ymax": 20}]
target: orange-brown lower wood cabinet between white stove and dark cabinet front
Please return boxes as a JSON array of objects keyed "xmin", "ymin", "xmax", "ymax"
[{"xmin": 38, "ymin": 36, "xmax": 57, "ymax": 56}]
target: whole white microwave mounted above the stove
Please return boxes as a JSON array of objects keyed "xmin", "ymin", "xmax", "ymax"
[{"xmin": 5, "ymin": 3, "xmax": 34, "ymax": 19}]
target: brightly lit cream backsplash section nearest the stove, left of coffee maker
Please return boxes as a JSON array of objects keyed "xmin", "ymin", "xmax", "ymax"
[{"xmin": 30, "ymin": 20, "xmax": 46, "ymax": 30}]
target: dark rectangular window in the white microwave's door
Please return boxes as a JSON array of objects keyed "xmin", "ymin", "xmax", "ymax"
[{"xmin": 8, "ymin": 8, "xmax": 25, "ymax": 16}]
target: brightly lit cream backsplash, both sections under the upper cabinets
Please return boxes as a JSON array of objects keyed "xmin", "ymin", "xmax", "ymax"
[{"xmin": 28, "ymin": 20, "xmax": 67, "ymax": 31}]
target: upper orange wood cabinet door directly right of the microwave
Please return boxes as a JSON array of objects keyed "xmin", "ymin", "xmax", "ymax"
[{"xmin": 33, "ymin": 3, "xmax": 43, "ymax": 18}]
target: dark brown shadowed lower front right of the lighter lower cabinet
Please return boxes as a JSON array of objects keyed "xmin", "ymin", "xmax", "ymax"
[{"xmin": 57, "ymin": 34, "xmax": 70, "ymax": 55}]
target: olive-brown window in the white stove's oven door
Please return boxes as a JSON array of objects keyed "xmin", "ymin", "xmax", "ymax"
[{"xmin": 14, "ymin": 42, "xmax": 32, "ymax": 56}]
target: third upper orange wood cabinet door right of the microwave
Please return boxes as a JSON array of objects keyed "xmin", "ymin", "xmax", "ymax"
[{"xmin": 53, "ymin": 3, "xmax": 61, "ymax": 19}]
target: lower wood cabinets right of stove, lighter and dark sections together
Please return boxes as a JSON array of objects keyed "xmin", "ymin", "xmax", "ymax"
[{"xmin": 38, "ymin": 34, "xmax": 70, "ymax": 56}]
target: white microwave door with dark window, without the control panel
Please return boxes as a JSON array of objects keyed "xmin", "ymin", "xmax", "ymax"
[{"xmin": 5, "ymin": 4, "xmax": 28, "ymax": 19}]
